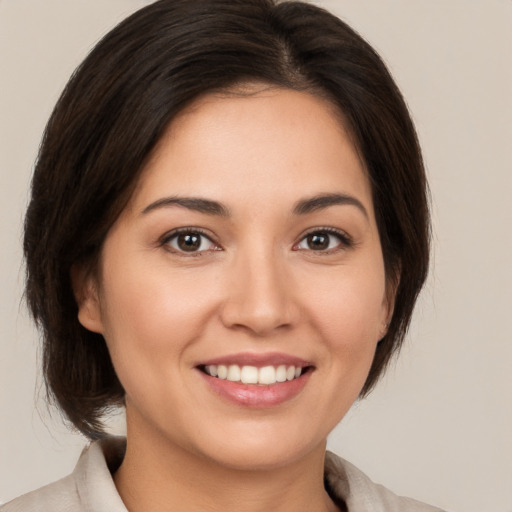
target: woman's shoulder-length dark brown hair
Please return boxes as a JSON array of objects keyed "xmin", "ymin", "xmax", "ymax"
[{"xmin": 24, "ymin": 0, "xmax": 429, "ymax": 438}]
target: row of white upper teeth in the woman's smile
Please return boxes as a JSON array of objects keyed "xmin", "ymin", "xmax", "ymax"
[{"xmin": 205, "ymin": 364, "xmax": 302, "ymax": 386}]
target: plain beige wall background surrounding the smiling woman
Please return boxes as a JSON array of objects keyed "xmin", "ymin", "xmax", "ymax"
[{"xmin": 0, "ymin": 0, "xmax": 512, "ymax": 512}]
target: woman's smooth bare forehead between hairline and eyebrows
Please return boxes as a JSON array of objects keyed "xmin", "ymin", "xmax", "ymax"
[{"xmin": 130, "ymin": 88, "xmax": 371, "ymax": 214}]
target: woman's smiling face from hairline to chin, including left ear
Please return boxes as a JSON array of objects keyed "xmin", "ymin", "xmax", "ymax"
[{"xmin": 79, "ymin": 89, "xmax": 390, "ymax": 468}]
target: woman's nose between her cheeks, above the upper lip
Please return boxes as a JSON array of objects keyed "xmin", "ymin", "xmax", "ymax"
[{"xmin": 221, "ymin": 247, "xmax": 299, "ymax": 337}]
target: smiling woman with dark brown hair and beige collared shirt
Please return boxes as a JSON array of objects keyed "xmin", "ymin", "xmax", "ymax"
[{"xmin": 2, "ymin": 0, "xmax": 435, "ymax": 512}]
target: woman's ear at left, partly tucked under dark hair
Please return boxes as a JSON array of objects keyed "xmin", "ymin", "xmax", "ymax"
[{"xmin": 71, "ymin": 264, "xmax": 103, "ymax": 334}]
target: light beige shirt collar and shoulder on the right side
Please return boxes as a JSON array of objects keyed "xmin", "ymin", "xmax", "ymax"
[{"xmin": 325, "ymin": 452, "xmax": 443, "ymax": 512}]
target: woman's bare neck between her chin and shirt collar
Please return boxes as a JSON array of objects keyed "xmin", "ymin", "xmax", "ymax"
[{"xmin": 114, "ymin": 420, "xmax": 338, "ymax": 512}]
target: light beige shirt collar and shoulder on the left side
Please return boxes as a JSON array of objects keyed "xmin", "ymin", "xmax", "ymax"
[{"xmin": 0, "ymin": 437, "xmax": 127, "ymax": 512}]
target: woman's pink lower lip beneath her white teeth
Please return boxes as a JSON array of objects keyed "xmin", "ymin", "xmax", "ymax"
[{"xmin": 200, "ymin": 371, "xmax": 311, "ymax": 409}]
